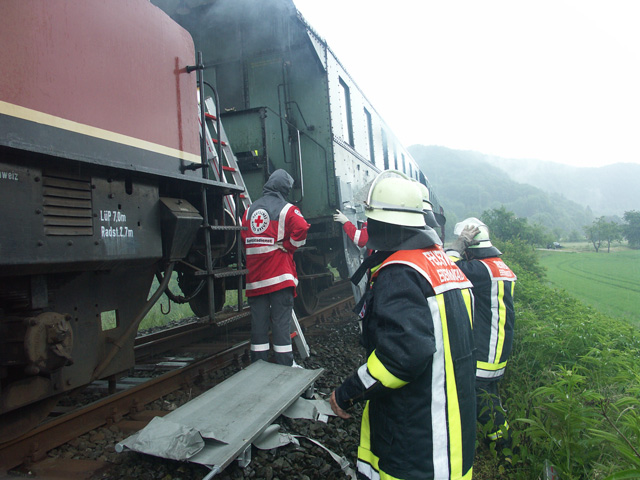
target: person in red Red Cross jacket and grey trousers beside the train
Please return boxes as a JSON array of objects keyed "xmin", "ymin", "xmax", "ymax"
[{"xmin": 242, "ymin": 169, "xmax": 309, "ymax": 366}]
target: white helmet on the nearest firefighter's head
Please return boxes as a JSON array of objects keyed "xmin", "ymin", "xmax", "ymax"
[{"xmin": 364, "ymin": 170, "xmax": 425, "ymax": 227}]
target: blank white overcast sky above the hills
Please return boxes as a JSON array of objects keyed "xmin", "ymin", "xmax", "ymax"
[{"xmin": 294, "ymin": 0, "xmax": 640, "ymax": 166}]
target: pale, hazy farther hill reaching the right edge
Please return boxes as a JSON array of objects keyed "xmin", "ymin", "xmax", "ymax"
[{"xmin": 488, "ymin": 157, "xmax": 640, "ymax": 217}]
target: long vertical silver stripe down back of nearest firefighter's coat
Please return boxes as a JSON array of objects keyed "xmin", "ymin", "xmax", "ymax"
[{"xmin": 427, "ymin": 297, "xmax": 454, "ymax": 478}]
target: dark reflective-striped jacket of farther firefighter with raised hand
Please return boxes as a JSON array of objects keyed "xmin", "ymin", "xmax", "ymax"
[{"xmin": 447, "ymin": 249, "xmax": 517, "ymax": 380}]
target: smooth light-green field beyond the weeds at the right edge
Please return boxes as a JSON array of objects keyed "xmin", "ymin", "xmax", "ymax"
[{"xmin": 540, "ymin": 248, "xmax": 640, "ymax": 326}]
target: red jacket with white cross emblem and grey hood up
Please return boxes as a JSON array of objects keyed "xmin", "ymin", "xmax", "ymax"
[{"xmin": 242, "ymin": 170, "xmax": 309, "ymax": 297}]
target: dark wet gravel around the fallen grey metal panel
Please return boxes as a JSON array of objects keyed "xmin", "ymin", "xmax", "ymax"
[{"xmin": 49, "ymin": 314, "xmax": 364, "ymax": 480}]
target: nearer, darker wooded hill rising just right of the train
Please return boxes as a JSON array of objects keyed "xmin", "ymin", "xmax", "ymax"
[{"xmin": 408, "ymin": 145, "xmax": 594, "ymax": 238}]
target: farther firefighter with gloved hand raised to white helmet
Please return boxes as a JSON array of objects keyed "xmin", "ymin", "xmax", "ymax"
[{"xmin": 447, "ymin": 217, "xmax": 517, "ymax": 447}]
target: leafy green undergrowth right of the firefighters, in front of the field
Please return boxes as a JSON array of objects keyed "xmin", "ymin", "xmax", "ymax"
[{"xmin": 496, "ymin": 242, "xmax": 640, "ymax": 480}]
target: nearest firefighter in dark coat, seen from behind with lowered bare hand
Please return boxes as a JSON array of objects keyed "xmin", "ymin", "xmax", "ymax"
[{"xmin": 330, "ymin": 174, "xmax": 476, "ymax": 479}]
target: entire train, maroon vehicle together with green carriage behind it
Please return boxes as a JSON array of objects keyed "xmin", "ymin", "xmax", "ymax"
[{"xmin": 0, "ymin": 0, "xmax": 440, "ymax": 442}]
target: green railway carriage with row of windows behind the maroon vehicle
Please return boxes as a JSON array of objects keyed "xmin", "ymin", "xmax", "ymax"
[{"xmin": 152, "ymin": 0, "xmax": 439, "ymax": 312}]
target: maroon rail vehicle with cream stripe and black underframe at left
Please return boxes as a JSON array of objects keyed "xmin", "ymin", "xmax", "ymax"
[{"xmin": 0, "ymin": 0, "xmax": 238, "ymax": 441}]
